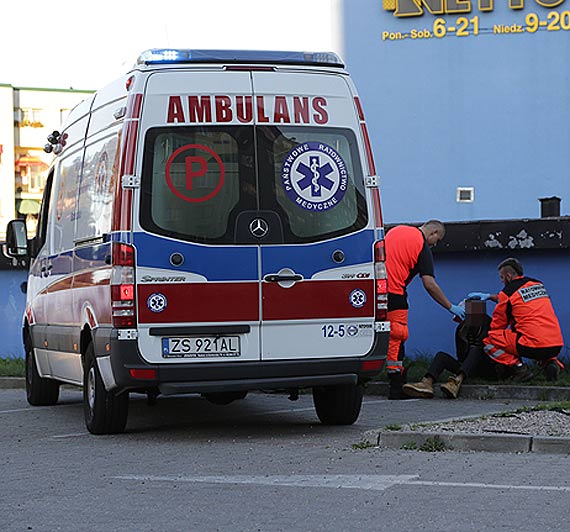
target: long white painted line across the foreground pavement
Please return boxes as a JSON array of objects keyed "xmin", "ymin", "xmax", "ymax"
[{"xmin": 113, "ymin": 475, "xmax": 570, "ymax": 492}]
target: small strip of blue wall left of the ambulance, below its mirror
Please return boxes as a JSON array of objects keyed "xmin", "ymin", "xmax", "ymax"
[{"xmin": 0, "ymin": 269, "xmax": 28, "ymax": 358}]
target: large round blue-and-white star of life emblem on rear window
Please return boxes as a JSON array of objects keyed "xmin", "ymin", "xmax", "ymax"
[{"xmin": 281, "ymin": 142, "xmax": 348, "ymax": 212}]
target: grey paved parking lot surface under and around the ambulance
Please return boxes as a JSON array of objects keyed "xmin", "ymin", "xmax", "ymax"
[{"xmin": 0, "ymin": 389, "xmax": 570, "ymax": 532}]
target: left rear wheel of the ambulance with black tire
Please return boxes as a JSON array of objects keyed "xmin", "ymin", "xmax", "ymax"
[{"xmin": 83, "ymin": 344, "xmax": 129, "ymax": 434}]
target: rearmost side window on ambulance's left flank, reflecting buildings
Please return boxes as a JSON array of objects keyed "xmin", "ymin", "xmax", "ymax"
[{"xmin": 75, "ymin": 134, "xmax": 119, "ymax": 239}]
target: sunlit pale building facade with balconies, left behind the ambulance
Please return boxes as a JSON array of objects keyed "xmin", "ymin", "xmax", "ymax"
[{"xmin": 0, "ymin": 84, "xmax": 92, "ymax": 239}]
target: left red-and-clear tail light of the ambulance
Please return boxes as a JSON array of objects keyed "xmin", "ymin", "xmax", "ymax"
[{"xmin": 111, "ymin": 242, "xmax": 137, "ymax": 329}]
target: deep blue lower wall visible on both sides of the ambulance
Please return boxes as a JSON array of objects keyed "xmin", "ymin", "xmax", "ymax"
[{"xmin": 0, "ymin": 254, "xmax": 570, "ymax": 366}]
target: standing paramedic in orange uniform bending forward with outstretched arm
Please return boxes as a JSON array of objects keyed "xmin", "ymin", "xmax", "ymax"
[{"xmin": 385, "ymin": 220, "xmax": 465, "ymax": 399}]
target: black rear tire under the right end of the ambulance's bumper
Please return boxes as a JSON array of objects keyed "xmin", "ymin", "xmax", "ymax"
[{"xmin": 313, "ymin": 384, "xmax": 362, "ymax": 425}]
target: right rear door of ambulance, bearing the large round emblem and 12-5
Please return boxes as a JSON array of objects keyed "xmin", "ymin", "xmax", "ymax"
[{"xmin": 250, "ymin": 70, "xmax": 374, "ymax": 360}]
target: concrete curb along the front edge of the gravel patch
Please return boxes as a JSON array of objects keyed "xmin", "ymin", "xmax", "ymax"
[{"xmin": 368, "ymin": 431, "xmax": 570, "ymax": 454}]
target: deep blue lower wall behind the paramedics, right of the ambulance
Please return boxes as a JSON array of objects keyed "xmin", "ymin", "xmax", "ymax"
[{"xmin": 406, "ymin": 249, "xmax": 570, "ymax": 358}]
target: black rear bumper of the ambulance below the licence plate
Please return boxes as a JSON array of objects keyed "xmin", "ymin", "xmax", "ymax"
[{"xmin": 96, "ymin": 330, "xmax": 389, "ymax": 395}]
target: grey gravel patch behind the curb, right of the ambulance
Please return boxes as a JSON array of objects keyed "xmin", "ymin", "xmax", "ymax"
[{"xmin": 401, "ymin": 410, "xmax": 570, "ymax": 437}]
